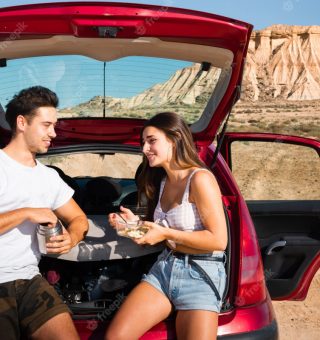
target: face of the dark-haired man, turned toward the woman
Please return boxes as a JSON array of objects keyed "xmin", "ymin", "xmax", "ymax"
[{"xmin": 23, "ymin": 107, "xmax": 57, "ymax": 153}]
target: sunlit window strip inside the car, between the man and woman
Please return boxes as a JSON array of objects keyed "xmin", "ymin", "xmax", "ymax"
[{"xmin": 39, "ymin": 152, "xmax": 142, "ymax": 179}]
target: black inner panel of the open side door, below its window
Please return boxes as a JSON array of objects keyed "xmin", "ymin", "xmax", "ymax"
[{"xmin": 247, "ymin": 201, "xmax": 320, "ymax": 299}]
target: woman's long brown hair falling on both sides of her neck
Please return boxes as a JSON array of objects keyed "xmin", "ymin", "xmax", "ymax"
[{"xmin": 137, "ymin": 112, "xmax": 206, "ymax": 221}]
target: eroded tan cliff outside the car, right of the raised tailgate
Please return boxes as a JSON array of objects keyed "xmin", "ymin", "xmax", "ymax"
[{"xmin": 242, "ymin": 25, "xmax": 320, "ymax": 101}]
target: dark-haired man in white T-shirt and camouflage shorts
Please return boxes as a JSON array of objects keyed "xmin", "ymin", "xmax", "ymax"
[{"xmin": 0, "ymin": 86, "xmax": 88, "ymax": 340}]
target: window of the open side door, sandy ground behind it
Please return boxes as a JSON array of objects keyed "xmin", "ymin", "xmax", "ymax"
[{"xmin": 231, "ymin": 141, "xmax": 320, "ymax": 200}]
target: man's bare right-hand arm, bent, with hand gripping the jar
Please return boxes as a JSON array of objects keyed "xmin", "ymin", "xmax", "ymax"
[{"xmin": 47, "ymin": 198, "xmax": 89, "ymax": 254}]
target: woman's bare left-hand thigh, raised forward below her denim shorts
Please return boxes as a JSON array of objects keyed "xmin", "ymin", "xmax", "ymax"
[{"xmin": 105, "ymin": 282, "xmax": 171, "ymax": 340}]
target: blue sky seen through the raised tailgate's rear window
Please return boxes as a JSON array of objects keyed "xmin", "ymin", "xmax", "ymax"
[{"xmin": 0, "ymin": 56, "xmax": 192, "ymax": 108}]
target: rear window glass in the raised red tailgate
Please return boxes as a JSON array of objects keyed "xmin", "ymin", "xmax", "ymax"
[{"xmin": 0, "ymin": 55, "xmax": 221, "ymax": 123}]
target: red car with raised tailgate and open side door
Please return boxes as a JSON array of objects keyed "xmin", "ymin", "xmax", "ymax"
[{"xmin": 0, "ymin": 2, "xmax": 320, "ymax": 339}]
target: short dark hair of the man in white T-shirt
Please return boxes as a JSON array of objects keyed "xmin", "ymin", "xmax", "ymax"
[{"xmin": 6, "ymin": 86, "xmax": 59, "ymax": 133}]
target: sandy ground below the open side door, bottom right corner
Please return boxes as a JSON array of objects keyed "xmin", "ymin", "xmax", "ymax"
[{"xmin": 273, "ymin": 270, "xmax": 320, "ymax": 340}]
